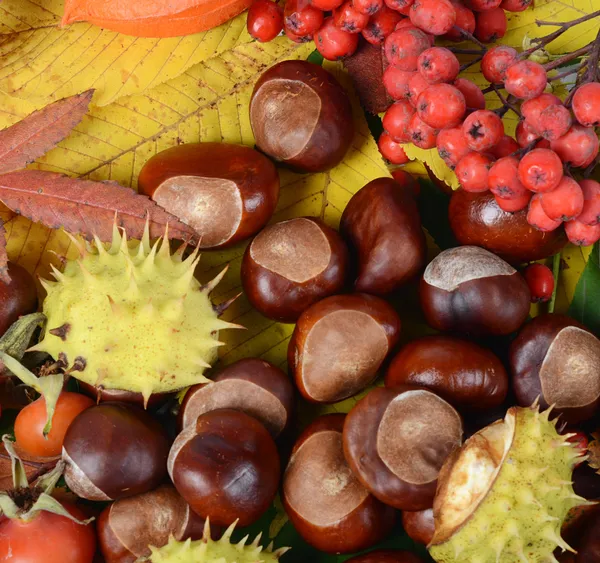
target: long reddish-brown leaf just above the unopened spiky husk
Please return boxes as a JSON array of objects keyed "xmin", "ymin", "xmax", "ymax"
[{"xmin": 0, "ymin": 170, "xmax": 198, "ymax": 242}]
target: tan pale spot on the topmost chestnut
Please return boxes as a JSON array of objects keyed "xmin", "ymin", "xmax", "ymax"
[{"xmin": 250, "ymin": 79, "xmax": 321, "ymax": 160}]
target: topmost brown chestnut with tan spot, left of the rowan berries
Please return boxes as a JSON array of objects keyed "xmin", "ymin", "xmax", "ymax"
[{"xmin": 250, "ymin": 61, "xmax": 354, "ymax": 172}]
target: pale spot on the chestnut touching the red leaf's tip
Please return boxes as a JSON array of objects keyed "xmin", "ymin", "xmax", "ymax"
[{"xmin": 153, "ymin": 176, "xmax": 243, "ymax": 247}]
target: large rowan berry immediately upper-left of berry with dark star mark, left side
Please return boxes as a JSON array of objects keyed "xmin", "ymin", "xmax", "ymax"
[{"xmin": 417, "ymin": 84, "xmax": 467, "ymax": 129}]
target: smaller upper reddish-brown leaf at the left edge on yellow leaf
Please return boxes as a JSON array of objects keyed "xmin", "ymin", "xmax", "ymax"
[{"xmin": 0, "ymin": 90, "xmax": 94, "ymax": 174}]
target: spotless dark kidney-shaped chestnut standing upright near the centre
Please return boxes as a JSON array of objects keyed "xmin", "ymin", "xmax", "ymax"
[{"xmin": 340, "ymin": 178, "xmax": 427, "ymax": 295}]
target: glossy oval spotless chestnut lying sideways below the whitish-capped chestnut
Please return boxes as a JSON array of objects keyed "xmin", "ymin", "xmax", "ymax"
[{"xmin": 385, "ymin": 335, "xmax": 508, "ymax": 411}]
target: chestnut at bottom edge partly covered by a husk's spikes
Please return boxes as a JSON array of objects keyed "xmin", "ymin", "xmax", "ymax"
[{"xmin": 96, "ymin": 485, "xmax": 205, "ymax": 563}]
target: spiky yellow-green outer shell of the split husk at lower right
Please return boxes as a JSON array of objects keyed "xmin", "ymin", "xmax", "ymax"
[{"xmin": 429, "ymin": 406, "xmax": 586, "ymax": 563}]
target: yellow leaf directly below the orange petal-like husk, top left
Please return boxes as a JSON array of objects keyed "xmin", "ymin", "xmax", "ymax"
[{"xmin": 0, "ymin": 0, "xmax": 252, "ymax": 108}]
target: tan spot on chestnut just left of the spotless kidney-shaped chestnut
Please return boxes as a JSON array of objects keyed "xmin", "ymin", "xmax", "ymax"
[{"xmin": 250, "ymin": 218, "xmax": 331, "ymax": 283}]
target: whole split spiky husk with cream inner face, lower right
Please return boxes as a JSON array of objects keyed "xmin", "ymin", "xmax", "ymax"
[{"xmin": 428, "ymin": 404, "xmax": 587, "ymax": 563}]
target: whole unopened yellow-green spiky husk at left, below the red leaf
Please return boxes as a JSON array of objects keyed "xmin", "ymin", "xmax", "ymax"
[{"xmin": 35, "ymin": 225, "xmax": 237, "ymax": 403}]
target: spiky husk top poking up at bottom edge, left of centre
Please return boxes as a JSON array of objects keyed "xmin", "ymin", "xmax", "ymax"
[{"xmin": 147, "ymin": 521, "xmax": 288, "ymax": 563}]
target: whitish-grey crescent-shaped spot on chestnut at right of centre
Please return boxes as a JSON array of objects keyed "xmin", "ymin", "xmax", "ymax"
[{"xmin": 423, "ymin": 246, "xmax": 516, "ymax": 291}]
